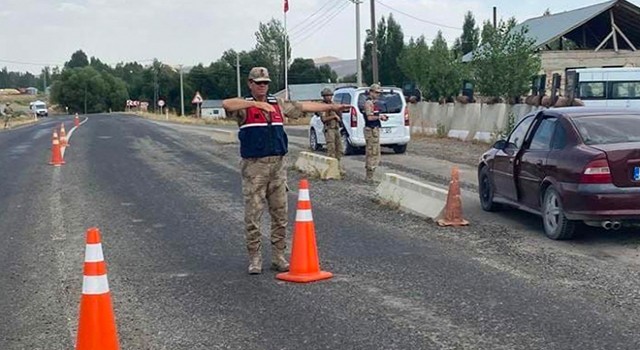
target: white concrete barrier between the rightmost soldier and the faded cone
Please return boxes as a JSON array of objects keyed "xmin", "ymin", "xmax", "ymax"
[{"xmin": 376, "ymin": 173, "xmax": 447, "ymax": 220}]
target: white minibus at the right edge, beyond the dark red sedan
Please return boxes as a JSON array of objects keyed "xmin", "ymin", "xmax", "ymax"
[{"xmin": 575, "ymin": 67, "xmax": 640, "ymax": 108}]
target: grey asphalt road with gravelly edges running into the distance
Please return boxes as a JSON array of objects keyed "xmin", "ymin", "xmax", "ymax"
[{"xmin": 0, "ymin": 115, "xmax": 640, "ymax": 349}]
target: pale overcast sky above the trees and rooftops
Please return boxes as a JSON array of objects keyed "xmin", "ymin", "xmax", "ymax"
[{"xmin": 0, "ymin": 0, "xmax": 639, "ymax": 73}]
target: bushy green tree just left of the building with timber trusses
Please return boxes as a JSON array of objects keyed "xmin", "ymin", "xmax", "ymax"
[{"xmin": 472, "ymin": 18, "xmax": 541, "ymax": 102}]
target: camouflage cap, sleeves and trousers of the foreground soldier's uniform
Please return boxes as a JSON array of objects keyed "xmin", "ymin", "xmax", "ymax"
[{"xmin": 229, "ymin": 69, "xmax": 303, "ymax": 274}]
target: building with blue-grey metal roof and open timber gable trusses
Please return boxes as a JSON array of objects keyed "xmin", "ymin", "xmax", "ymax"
[{"xmin": 462, "ymin": 0, "xmax": 640, "ymax": 91}]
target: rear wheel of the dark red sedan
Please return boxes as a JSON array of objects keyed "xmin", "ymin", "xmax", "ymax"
[{"xmin": 542, "ymin": 186, "xmax": 576, "ymax": 240}]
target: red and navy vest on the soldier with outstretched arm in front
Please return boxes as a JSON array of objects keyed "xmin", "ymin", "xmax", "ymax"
[{"xmin": 238, "ymin": 96, "xmax": 289, "ymax": 158}]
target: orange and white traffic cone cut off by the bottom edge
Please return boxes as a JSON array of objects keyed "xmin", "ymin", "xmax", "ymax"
[{"xmin": 76, "ymin": 227, "xmax": 120, "ymax": 350}]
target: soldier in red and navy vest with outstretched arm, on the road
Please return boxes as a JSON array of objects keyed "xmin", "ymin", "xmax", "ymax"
[{"xmin": 222, "ymin": 67, "xmax": 345, "ymax": 274}]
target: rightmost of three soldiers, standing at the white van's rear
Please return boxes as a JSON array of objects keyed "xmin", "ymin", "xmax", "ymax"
[{"xmin": 364, "ymin": 84, "xmax": 389, "ymax": 182}]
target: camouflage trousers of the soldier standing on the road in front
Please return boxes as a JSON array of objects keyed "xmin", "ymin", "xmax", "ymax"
[{"xmin": 241, "ymin": 156, "xmax": 288, "ymax": 255}]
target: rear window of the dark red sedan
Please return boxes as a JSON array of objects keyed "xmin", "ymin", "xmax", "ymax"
[{"xmin": 572, "ymin": 115, "xmax": 640, "ymax": 145}]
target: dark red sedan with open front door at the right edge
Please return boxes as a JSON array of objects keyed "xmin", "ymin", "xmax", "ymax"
[{"xmin": 478, "ymin": 107, "xmax": 640, "ymax": 239}]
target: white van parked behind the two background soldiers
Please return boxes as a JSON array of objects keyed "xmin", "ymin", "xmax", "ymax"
[{"xmin": 309, "ymin": 86, "xmax": 411, "ymax": 154}]
